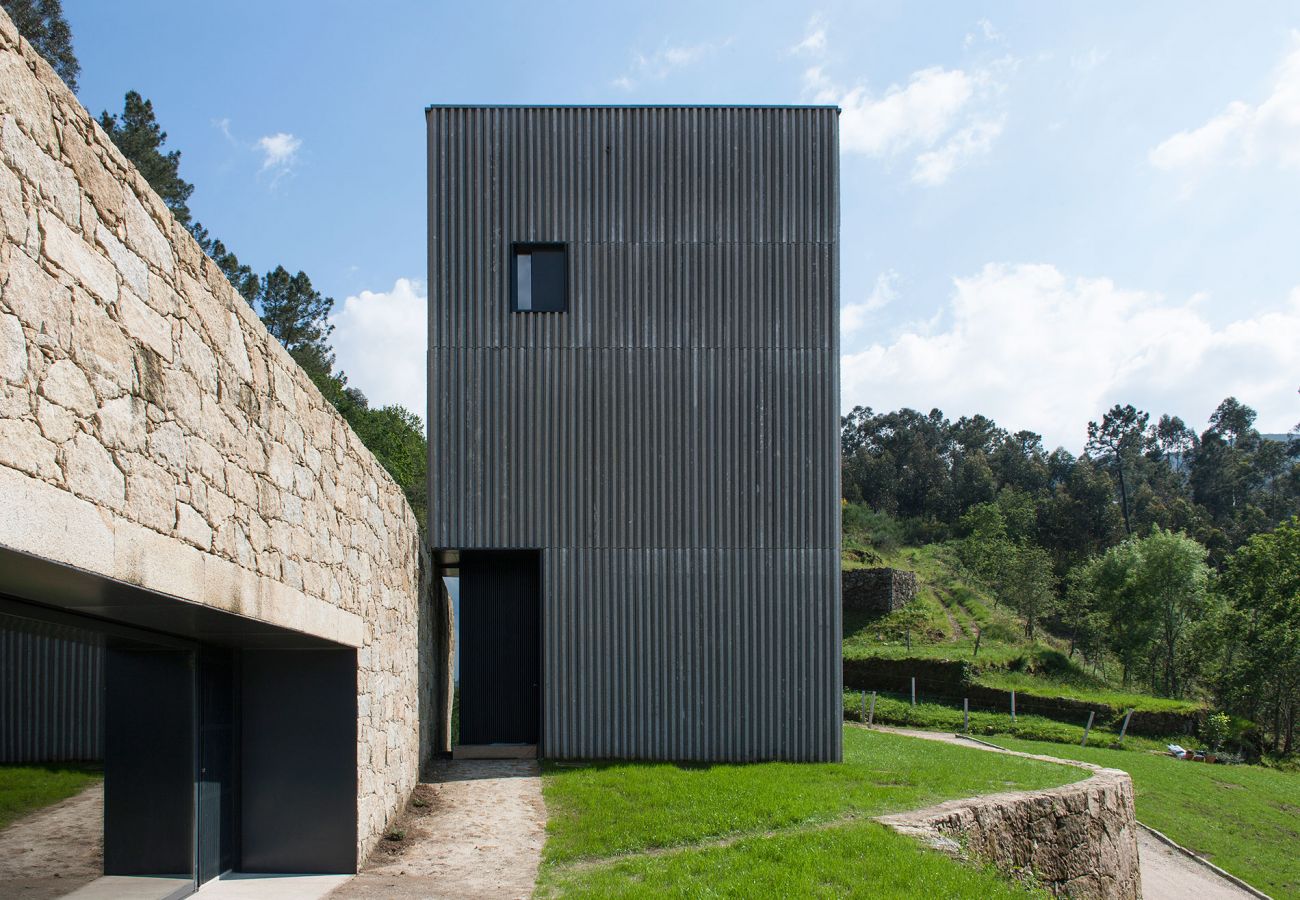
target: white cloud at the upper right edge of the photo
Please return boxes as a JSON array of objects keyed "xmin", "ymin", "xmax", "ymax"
[{"xmin": 1148, "ymin": 31, "xmax": 1300, "ymax": 170}]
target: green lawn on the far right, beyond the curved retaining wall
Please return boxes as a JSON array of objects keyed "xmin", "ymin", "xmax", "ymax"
[{"xmin": 991, "ymin": 737, "xmax": 1300, "ymax": 900}]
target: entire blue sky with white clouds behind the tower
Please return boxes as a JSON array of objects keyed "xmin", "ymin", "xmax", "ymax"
[{"xmin": 65, "ymin": 0, "xmax": 1300, "ymax": 450}]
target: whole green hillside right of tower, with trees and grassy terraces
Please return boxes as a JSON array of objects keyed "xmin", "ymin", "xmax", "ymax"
[{"xmin": 841, "ymin": 397, "xmax": 1300, "ymax": 758}]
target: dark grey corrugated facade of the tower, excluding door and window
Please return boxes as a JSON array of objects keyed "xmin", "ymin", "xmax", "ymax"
[{"xmin": 428, "ymin": 107, "xmax": 840, "ymax": 760}]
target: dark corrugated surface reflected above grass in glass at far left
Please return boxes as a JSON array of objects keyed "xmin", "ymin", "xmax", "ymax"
[{"xmin": 0, "ymin": 614, "xmax": 104, "ymax": 762}]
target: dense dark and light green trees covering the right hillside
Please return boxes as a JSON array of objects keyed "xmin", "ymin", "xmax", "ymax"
[{"xmin": 841, "ymin": 397, "xmax": 1300, "ymax": 753}]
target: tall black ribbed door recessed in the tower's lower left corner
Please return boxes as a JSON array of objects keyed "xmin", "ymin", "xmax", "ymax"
[{"xmin": 458, "ymin": 550, "xmax": 541, "ymax": 744}]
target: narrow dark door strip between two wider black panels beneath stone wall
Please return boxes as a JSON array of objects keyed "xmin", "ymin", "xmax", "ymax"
[{"xmin": 198, "ymin": 646, "xmax": 238, "ymax": 884}]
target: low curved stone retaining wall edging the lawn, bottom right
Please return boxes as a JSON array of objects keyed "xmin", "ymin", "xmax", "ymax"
[{"xmin": 878, "ymin": 754, "xmax": 1141, "ymax": 900}]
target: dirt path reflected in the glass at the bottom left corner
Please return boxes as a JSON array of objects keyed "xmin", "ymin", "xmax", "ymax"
[{"xmin": 0, "ymin": 782, "xmax": 104, "ymax": 900}]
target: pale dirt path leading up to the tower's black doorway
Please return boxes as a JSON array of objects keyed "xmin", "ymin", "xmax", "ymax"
[{"xmin": 330, "ymin": 760, "xmax": 546, "ymax": 900}]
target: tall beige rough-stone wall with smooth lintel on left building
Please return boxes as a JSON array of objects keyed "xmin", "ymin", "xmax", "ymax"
[{"xmin": 0, "ymin": 14, "xmax": 428, "ymax": 860}]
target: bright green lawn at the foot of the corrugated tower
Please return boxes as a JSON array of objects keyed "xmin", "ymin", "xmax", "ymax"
[{"xmin": 541, "ymin": 727, "xmax": 1086, "ymax": 896}]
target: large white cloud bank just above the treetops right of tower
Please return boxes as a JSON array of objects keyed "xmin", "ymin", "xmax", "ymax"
[{"xmin": 841, "ymin": 264, "xmax": 1300, "ymax": 451}]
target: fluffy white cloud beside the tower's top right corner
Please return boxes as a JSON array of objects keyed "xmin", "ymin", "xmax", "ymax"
[{"xmin": 803, "ymin": 60, "xmax": 1014, "ymax": 186}]
